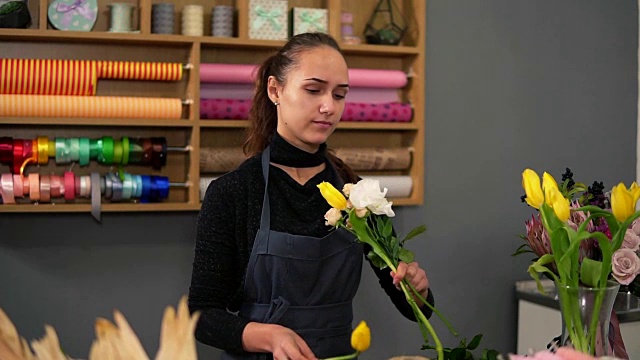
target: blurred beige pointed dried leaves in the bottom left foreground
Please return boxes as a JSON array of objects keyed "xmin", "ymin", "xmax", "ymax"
[{"xmin": 0, "ymin": 296, "xmax": 200, "ymax": 360}]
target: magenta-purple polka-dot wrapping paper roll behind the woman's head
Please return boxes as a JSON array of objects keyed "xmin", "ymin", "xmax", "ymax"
[{"xmin": 200, "ymin": 99, "xmax": 413, "ymax": 122}]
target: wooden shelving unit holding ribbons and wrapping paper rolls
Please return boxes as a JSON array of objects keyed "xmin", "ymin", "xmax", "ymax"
[{"xmin": 0, "ymin": 0, "xmax": 426, "ymax": 212}]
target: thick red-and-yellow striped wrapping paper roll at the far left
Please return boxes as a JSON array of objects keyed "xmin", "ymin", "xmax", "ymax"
[{"xmin": 0, "ymin": 59, "xmax": 98, "ymax": 96}]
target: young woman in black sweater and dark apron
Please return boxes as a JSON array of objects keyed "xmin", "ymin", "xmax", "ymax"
[{"xmin": 189, "ymin": 33, "xmax": 433, "ymax": 360}]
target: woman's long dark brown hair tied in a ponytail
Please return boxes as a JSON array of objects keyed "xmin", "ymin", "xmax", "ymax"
[{"xmin": 242, "ymin": 32, "xmax": 357, "ymax": 182}]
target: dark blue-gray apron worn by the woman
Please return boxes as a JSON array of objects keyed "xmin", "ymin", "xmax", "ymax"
[{"xmin": 221, "ymin": 147, "xmax": 363, "ymax": 360}]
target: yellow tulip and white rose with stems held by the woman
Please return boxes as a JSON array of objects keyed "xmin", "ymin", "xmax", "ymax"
[{"xmin": 318, "ymin": 179, "xmax": 499, "ymax": 360}]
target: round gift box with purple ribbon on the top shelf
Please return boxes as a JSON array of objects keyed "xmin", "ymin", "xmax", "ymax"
[{"xmin": 48, "ymin": 0, "xmax": 98, "ymax": 31}]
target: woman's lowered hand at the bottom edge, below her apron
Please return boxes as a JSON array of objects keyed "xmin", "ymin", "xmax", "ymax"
[{"xmin": 242, "ymin": 322, "xmax": 317, "ymax": 360}]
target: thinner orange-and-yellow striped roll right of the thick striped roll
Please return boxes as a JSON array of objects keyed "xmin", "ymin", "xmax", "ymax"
[{"xmin": 97, "ymin": 61, "xmax": 182, "ymax": 81}]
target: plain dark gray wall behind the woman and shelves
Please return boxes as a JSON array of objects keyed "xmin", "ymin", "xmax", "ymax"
[{"xmin": 0, "ymin": 0, "xmax": 637, "ymax": 360}]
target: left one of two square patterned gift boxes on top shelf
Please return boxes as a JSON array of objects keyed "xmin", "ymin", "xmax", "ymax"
[{"xmin": 249, "ymin": 0, "xmax": 289, "ymax": 40}]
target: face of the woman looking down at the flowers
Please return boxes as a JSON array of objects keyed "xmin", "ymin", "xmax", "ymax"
[{"xmin": 268, "ymin": 46, "xmax": 349, "ymax": 152}]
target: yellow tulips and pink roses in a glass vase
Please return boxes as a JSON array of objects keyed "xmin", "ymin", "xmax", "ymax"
[{"xmin": 514, "ymin": 169, "xmax": 640, "ymax": 355}]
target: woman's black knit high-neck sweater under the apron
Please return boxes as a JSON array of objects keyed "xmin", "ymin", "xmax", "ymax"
[{"xmin": 189, "ymin": 135, "xmax": 433, "ymax": 353}]
